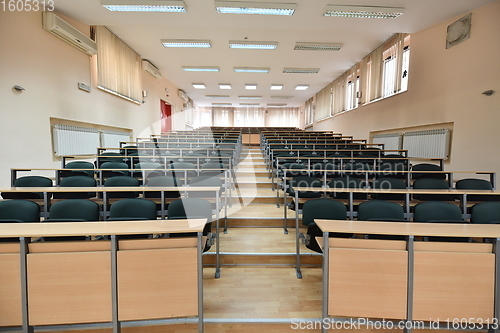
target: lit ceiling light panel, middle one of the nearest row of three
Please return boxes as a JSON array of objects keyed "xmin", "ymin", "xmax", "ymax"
[{"xmin": 215, "ymin": 1, "xmax": 297, "ymax": 15}]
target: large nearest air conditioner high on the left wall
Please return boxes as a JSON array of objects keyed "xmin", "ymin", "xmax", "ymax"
[{"xmin": 42, "ymin": 12, "xmax": 97, "ymax": 55}]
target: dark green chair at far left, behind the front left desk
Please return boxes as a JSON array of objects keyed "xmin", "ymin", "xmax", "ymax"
[{"xmin": 0, "ymin": 199, "xmax": 40, "ymax": 243}]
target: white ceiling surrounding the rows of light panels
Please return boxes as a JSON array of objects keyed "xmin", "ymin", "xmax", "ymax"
[{"xmin": 56, "ymin": 0, "xmax": 496, "ymax": 107}]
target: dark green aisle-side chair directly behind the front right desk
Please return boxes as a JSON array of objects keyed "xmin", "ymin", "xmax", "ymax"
[{"xmin": 302, "ymin": 198, "xmax": 352, "ymax": 253}]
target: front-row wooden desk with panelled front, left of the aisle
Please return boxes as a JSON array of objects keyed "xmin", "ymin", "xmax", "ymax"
[{"xmin": 0, "ymin": 219, "xmax": 207, "ymax": 333}]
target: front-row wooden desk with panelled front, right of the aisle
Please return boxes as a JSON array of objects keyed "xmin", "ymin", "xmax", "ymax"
[{"xmin": 315, "ymin": 220, "xmax": 500, "ymax": 332}]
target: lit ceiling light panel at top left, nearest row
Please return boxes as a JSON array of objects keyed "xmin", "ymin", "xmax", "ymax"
[{"xmin": 101, "ymin": 0, "xmax": 187, "ymax": 13}]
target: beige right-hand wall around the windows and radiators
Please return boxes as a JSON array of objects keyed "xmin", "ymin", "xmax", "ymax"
[{"xmin": 314, "ymin": 1, "xmax": 500, "ymax": 176}]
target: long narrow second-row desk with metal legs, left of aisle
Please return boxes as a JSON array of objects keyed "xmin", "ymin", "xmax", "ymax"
[{"xmin": 0, "ymin": 186, "xmax": 223, "ymax": 278}]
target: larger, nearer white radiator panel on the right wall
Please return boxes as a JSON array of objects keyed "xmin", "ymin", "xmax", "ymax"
[{"xmin": 403, "ymin": 128, "xmax": 450, "ymax": 159}]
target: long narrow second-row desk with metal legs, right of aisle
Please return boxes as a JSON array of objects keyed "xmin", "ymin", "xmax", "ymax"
[{"xmin": 292, "ymin": 187, "xmax": 500, "ymax": 279}]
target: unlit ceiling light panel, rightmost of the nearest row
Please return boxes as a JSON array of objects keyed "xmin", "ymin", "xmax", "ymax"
[{"xmin": 323, "ymin": 5, "xmax": 404, "ymax": 18}]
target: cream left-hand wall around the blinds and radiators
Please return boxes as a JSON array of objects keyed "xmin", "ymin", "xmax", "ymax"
[{"xmin": 0, "ymin": 11, "xmax": 185, "ymax": 186}]
